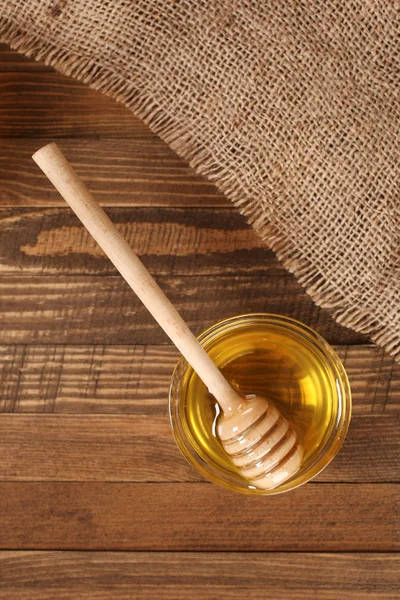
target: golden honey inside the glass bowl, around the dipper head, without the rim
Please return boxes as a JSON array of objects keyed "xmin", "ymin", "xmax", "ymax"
[{"xmin": 181, "ymin": 324, "xmax": 338, "ymax": 488}]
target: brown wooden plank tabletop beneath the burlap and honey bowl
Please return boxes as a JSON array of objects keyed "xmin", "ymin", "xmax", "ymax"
[{"xmin": 0, "ymin": 46, "xmax": 400, "ymax": 600}]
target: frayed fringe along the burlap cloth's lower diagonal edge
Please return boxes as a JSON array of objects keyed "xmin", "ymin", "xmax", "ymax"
[{"xmin": 0, "ymin": 17, "xmax": 400, "ymax": 362}]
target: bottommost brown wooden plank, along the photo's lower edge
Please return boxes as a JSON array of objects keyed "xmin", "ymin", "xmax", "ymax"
[{"xmin": 0, "ymin": 551, "xmax": 400, "ymax": 600}]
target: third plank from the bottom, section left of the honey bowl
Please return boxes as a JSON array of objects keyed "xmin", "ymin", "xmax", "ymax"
[{"xmin": 0, "ymin": 418, "xmax": 198, "ymax": 482}]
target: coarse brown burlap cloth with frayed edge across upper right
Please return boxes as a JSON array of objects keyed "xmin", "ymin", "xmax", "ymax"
[{"xmin": 0, "ymin": 0, "xmax": 400, "ymax": 359}]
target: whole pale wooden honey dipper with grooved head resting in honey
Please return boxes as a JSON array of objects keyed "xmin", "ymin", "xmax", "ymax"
[{"xmin": 32, "ymin": 143, "xmax": 303, "ymax": 489}]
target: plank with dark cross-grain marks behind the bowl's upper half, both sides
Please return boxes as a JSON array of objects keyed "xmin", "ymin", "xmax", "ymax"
[{"xmin": 0, "ymin": 344, "xmax": 400, "ymax": 416}]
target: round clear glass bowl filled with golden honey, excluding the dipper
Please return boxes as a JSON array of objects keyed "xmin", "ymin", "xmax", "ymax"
[{"xmin": 170, "ymin": 314, "xmax": 351, "ymax": 494}]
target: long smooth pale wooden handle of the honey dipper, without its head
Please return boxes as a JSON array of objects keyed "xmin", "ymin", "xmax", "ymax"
[{"xmin": 32, "ymin": 143, "xmax": 243, "ymax": 413}]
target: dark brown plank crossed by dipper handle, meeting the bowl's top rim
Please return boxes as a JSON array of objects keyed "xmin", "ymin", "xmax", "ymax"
[{"xmin": 0, "ymin": 272, "xmax": 367, "ymax": 344}]
